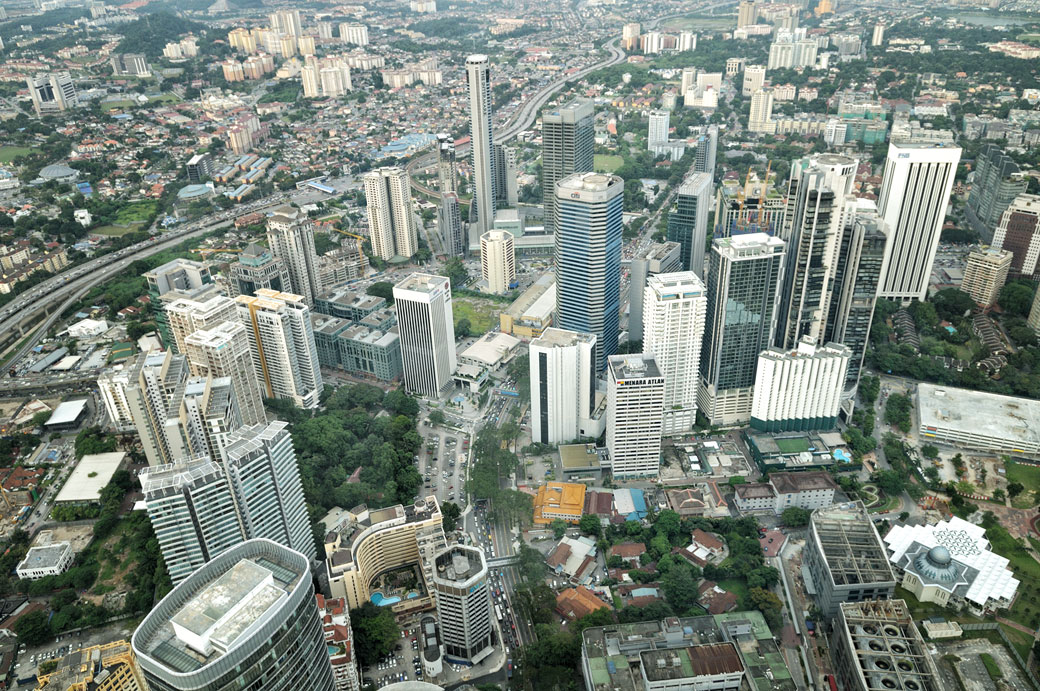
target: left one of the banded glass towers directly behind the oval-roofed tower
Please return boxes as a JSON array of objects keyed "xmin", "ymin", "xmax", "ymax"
[{"xmin": 139, "ymin": 456, "xmax": 245, "ymax": 585}]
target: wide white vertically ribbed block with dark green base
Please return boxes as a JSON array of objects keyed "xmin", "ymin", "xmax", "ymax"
[{"xmin": 751, "ymin": 338, "xmax": 852, "ymax": 432}]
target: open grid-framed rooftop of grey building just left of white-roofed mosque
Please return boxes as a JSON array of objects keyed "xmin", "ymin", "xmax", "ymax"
[{"xmin": 809, "ymin": 502, "xmax": 895, "ymax": 586}]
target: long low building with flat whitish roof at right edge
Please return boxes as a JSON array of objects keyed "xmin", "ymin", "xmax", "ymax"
[{"xmin": 917, "ymin": 383, "xmax": 1040, "ymax": 451}]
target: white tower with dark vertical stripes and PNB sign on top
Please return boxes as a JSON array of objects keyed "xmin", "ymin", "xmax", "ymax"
[{"xmin": 878, "ymin": 143, "xmax": 961, "ymax": 301}]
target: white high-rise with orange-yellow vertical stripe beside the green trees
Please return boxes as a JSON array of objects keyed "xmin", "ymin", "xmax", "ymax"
[{"xmin": 235, "ymin": 289, "xmax": 324, "ymax": 408}]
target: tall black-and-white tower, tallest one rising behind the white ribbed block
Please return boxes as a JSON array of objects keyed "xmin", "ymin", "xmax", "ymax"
[{"xmin": 775, "ymin": 154, "xmax": 859, "ymax": 350}]
